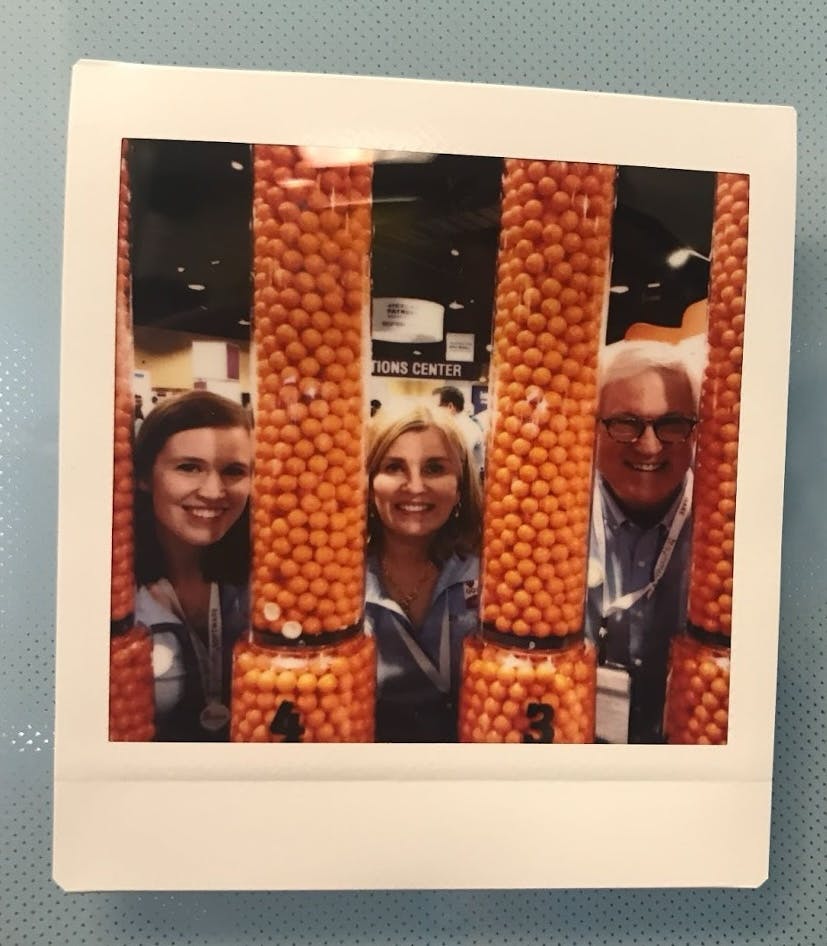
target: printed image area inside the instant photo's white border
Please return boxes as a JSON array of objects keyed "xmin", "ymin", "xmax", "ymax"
[{"xmin": 110, "ymin": 140, "xmax": 736, "ymax": 744}]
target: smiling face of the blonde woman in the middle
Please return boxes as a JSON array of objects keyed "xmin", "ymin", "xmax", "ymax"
[{"xmin": 371, "ymin": 427, "xmax": 461, "ymax": 539}]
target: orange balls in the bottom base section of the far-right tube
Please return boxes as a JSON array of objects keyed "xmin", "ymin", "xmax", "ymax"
[{"xmin": 664, "ymin": 636, "xmax": 729, "ymax": 746}]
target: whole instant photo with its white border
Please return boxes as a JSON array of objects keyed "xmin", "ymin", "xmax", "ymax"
[{"xmin": 54, "ymin": 61, "xmax": 795, "ymax": 890}]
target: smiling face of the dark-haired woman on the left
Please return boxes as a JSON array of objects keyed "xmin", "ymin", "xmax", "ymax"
[{"xmin": 148, "ymin": 427, "xmax": 252, "ymax": 548}]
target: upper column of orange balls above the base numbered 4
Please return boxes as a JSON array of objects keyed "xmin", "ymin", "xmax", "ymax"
[{"xmin": 252, "ymin": 145, "xmax": 372, "ymax": 637}]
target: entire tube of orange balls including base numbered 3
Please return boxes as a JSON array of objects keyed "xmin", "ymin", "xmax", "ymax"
[{"xmin": 459, "ymin": 159, "xmax": 616, "ymax": 743}]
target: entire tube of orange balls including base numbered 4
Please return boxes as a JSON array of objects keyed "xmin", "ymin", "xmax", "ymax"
[{"xmin": 230, "ymin": 145, "xmax": 376, "ymax": 742}]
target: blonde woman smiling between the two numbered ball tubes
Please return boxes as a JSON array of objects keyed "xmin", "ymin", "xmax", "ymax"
[{"xmin": 366, "ymin": 406, "xmax": 482, "ymax": 742}]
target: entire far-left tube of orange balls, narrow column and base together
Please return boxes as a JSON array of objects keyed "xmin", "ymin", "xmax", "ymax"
[{"xmin": 109, "ymin": 141, "xmax": 155, "ymax": 742}]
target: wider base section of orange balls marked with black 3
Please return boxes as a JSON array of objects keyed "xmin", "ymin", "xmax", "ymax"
[{"xmin": 459, "ymin": 637, "xmax": 597, "ymax": 743}]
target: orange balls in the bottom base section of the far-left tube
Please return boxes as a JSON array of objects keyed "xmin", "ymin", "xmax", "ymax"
[{"xmin": 109, "ymin": 627, "xmax": 155, "ymax": 742}]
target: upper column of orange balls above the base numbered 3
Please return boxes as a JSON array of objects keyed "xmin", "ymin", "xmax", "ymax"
[{"xmin": 482, "ymin": 160, "xmax": 615, "ymax": 638}]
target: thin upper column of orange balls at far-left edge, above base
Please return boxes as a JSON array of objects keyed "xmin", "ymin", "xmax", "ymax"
[{"xmin": 110, "ymin": 145, "xmax": 135, "ymax": 621}]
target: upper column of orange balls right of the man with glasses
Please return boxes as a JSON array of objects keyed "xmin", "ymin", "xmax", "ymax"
[{"xmin": 689, "ymin": 174, "xmax": 749, "ymax": 634}]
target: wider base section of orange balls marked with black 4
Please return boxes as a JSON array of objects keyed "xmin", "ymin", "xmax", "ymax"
[{"xmin": 230, "ymin": 634, "xmax": 376, "ymax": 742}]
